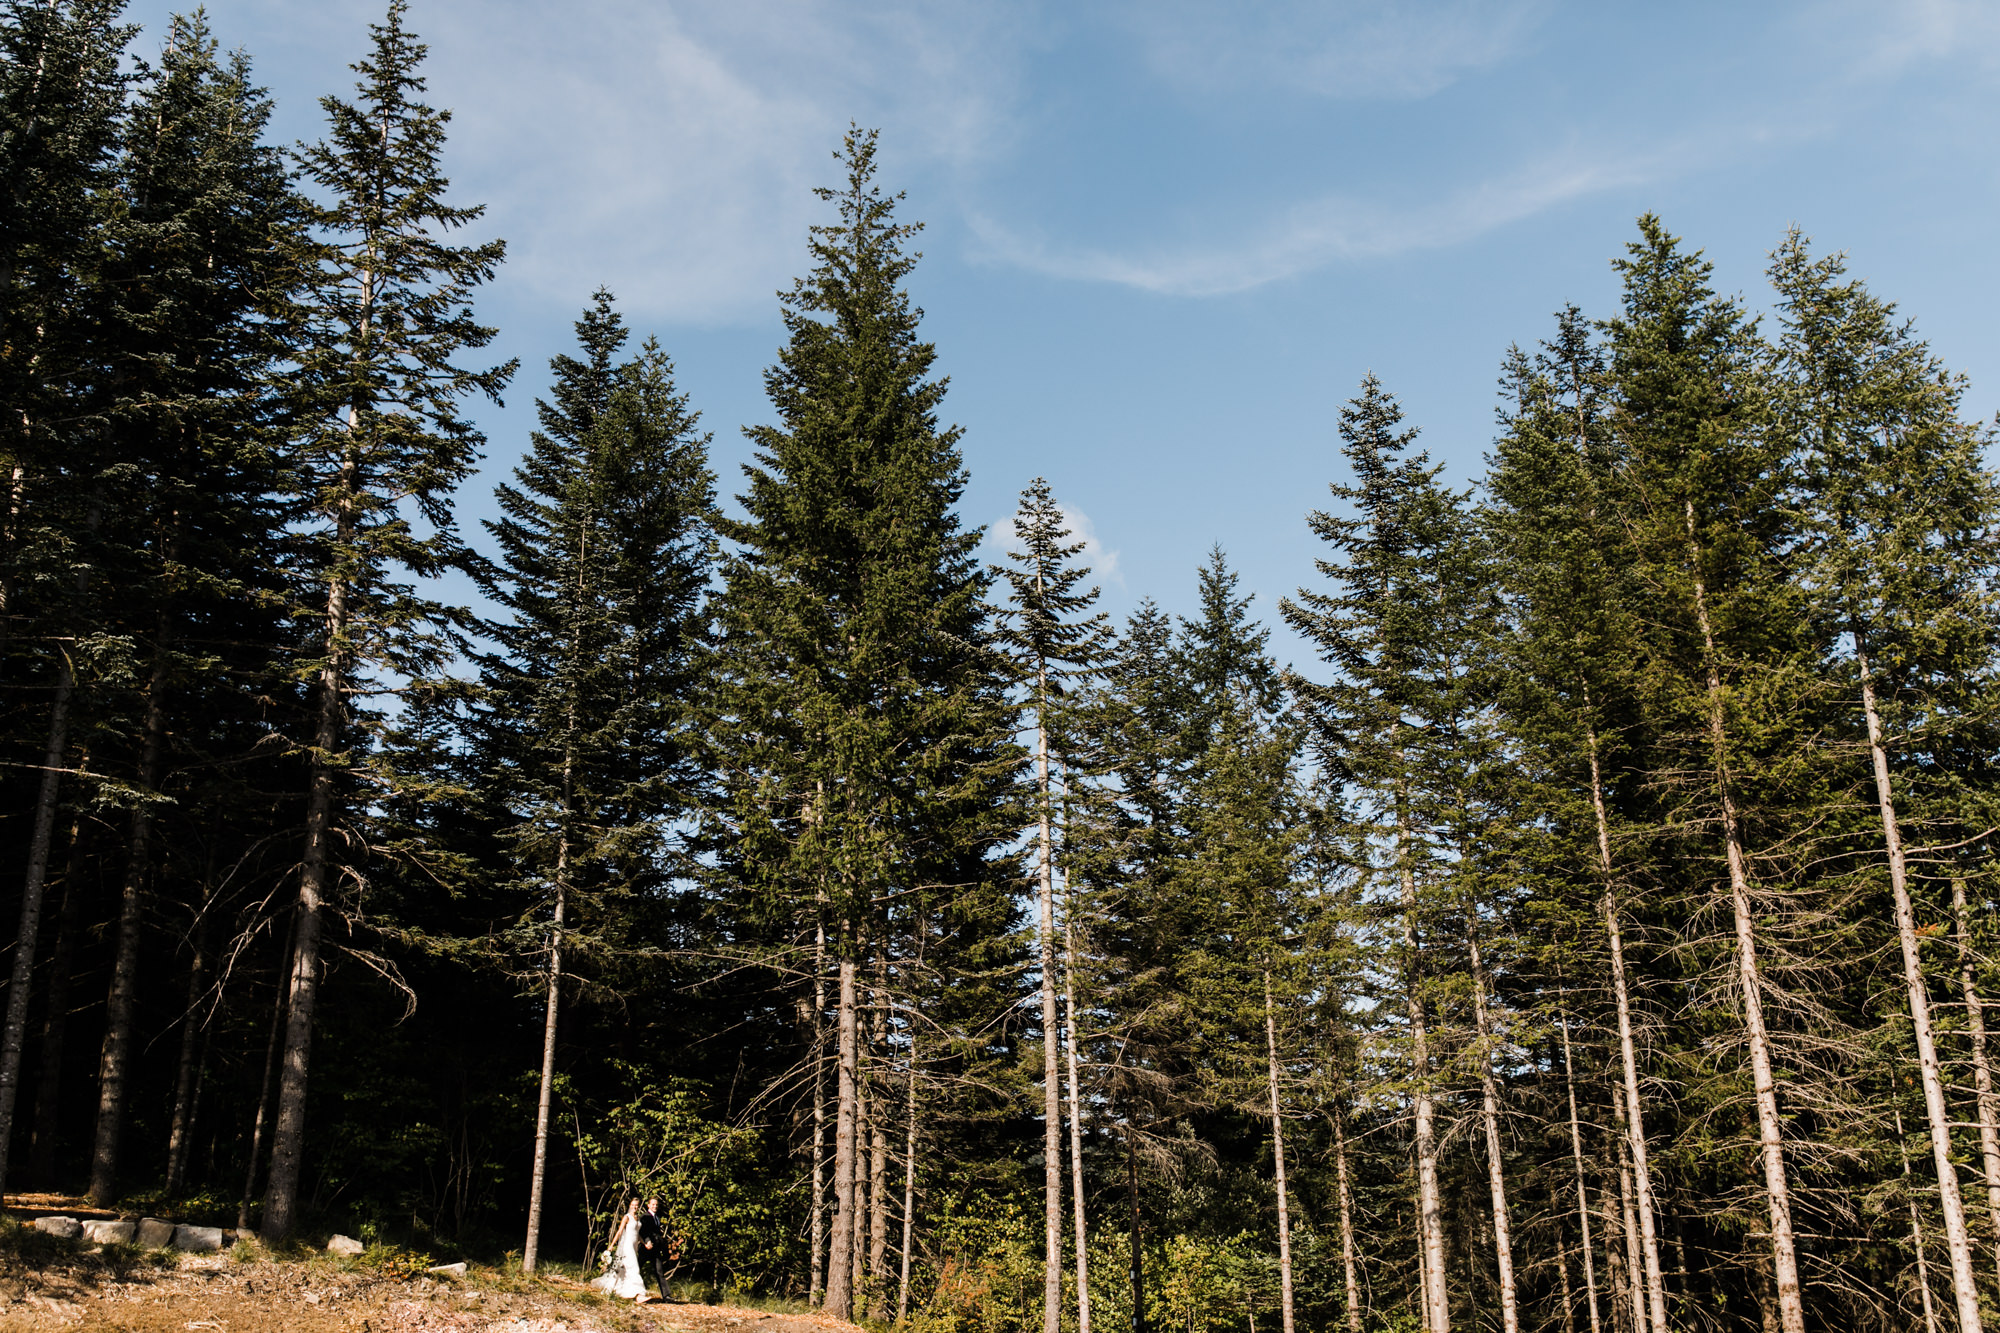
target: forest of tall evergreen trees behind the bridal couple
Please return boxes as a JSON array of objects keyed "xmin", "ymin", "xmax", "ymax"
[{"xmin": 11, "ymin": 0, "xmax": 2000, "ymax": 1333}]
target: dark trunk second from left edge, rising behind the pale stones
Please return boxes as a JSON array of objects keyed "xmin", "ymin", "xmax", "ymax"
[{"xmin": 90, "ymin": 614, "xmax": 168, "ymax": 1209}]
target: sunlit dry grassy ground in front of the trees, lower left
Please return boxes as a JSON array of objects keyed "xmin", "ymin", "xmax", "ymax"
[{"xmin": 0, "ymin": 1200, "xmax": 862, "ymax": 1333}]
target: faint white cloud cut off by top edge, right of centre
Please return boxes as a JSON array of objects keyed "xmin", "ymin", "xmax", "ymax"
[{"xmin": 1120, "ymin": 0, "xmax": 1552, "ymax": 98}]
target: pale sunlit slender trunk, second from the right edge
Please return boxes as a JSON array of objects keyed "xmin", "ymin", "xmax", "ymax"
[{"xmin": 1852, "ymin": 622, "xmax": 1984, "ymax": 1333}]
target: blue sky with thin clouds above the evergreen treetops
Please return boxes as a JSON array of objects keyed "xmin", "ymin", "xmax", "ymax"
[{"xmin": 128, "ymin": 0, "xmax": 2000, "ymax": 658}]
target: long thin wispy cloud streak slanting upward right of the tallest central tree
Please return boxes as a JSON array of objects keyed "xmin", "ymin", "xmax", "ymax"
[{"xmin": 974, "ymin": 132, "xmax": 1704, "ymax": 296}]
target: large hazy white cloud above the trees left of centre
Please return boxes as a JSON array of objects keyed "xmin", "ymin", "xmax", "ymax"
[{"xmin": 418, "ymin": 0, "xmax": 1016, "ymax": 320}]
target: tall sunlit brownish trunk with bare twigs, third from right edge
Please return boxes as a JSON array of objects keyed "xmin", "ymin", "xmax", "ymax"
[{"xmin": 1686, "ymin": 510, "xmax": 1816, "ymax": 1333}]
